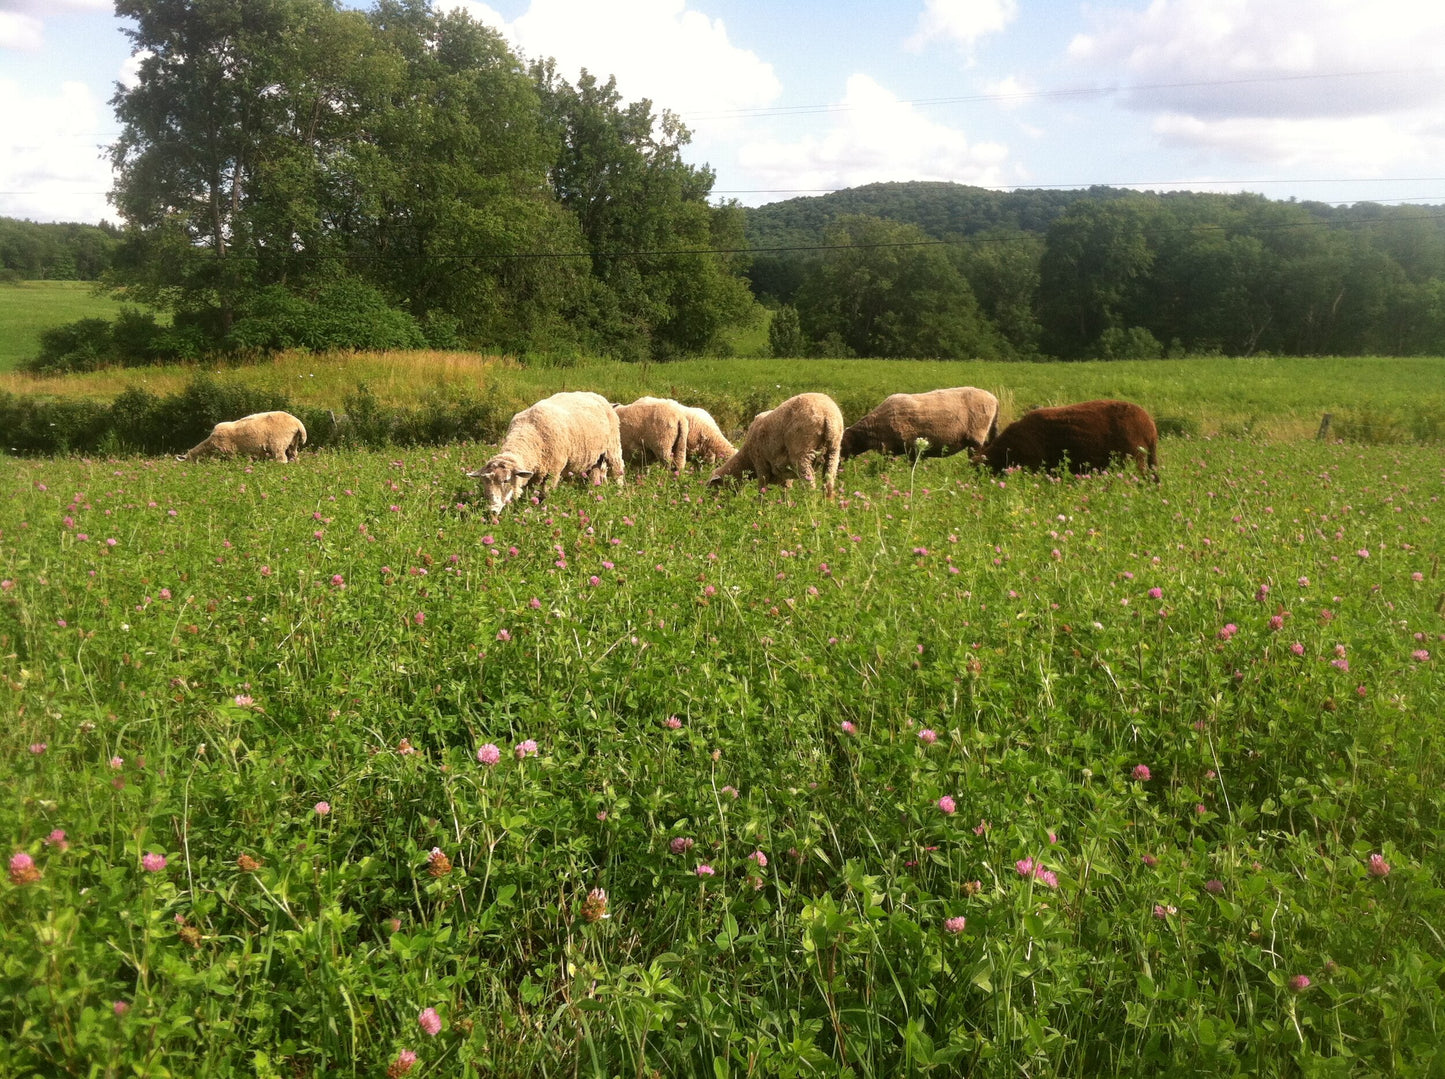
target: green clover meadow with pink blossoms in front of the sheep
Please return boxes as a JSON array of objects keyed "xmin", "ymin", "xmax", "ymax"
[{"xmin": 0, "ymin": 392, "xmax": 1445, "ymax": 1076}]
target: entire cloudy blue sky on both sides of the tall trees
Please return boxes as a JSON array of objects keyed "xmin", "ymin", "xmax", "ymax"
[{"xmin": 0, "ymin": 0, "xmax": 1445, "ymax": 222}]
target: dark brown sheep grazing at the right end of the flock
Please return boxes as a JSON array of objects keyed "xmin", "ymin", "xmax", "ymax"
[{"xmin": 972, "ymin": 402, "xmax": 1159, "ymax": 481}]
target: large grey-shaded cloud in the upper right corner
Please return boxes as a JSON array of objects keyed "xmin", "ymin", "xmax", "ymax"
[{"xmin": 1068, "ymin": 0, "xmax": 1445, "ymax": 176}]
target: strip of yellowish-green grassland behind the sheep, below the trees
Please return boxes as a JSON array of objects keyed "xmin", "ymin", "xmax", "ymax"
[{"xmin": 0, "ymin": 352, "xmax": 1445, "ymax": 442}]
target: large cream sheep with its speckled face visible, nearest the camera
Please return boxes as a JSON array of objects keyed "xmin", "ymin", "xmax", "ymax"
[{"xmin": 467, "ymin": 393, "xmax": 623, "ymax": 516}]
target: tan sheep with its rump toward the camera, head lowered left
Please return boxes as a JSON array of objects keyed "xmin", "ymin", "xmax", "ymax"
[{"xmin": 708, "ymin": 393, "xmax": 842, "ymax": 498}]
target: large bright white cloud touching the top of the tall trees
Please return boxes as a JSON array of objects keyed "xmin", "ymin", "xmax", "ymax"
[{"xmin": 438, "ymin": 0, "xmax": 782, "ymax": 116}]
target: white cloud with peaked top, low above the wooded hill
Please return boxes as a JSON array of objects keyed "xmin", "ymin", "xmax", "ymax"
[{"xmin": 738, "ymin": 75, "xmax": 1009, "ymax": 191}]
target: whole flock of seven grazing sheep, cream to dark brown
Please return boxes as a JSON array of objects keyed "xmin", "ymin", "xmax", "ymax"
[{"xmin": 181, "ymin": 386, "xmax": 1159, "ymax": 514}]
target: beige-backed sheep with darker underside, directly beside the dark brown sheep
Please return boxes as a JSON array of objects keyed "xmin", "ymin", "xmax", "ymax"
[{"xmin": 842, "ymin": 386, "xmax": 998, "ymax": 459}]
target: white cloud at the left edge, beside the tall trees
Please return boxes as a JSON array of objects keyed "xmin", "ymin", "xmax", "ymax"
[{"xmin": 0, "ymin": 78, "xmax": 114, "ymax": 221}]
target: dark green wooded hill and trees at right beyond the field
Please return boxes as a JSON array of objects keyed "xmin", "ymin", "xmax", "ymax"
[{"xmin": 747, "ymin": 183, "xmax": 1445, "ymax": 360}]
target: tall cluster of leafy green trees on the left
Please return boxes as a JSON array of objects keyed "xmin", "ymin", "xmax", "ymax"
[{"xmin": 73, "ymin": 0, "xmax": 762, "ymax": 369}]
